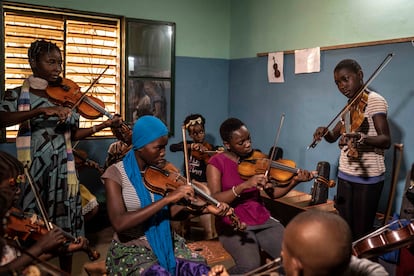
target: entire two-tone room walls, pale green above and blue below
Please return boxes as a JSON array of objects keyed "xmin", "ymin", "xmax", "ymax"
[{"xmin": 0, "ymin": 0, "xmax": 414, "ymax": 216}]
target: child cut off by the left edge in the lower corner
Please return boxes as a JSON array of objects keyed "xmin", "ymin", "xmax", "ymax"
[{"xmin": 0, "ymin": 151, "xmax": 86, "ymax": 275}]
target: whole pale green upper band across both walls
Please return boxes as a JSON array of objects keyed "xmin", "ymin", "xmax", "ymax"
[{"xmin": 7, "ymin": 0, "xmax": 414, "ymax": 59}]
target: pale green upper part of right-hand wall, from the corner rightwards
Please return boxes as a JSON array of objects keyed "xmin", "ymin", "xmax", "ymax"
[{"xmin": 230, "ymin": 0, "xmax": 414, "ymax": 58}]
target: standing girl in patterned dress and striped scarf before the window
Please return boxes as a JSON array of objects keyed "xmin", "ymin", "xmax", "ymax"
[{"xmin": 0, "ymin": 40, "xmax": 121, "ymax": 272}]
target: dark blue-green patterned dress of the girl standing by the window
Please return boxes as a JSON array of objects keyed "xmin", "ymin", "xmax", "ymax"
[{"xmin": 0, "ymin": 88, "xmax": 84, "ymax": 236}]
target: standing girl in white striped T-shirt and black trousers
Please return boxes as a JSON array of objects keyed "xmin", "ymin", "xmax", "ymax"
[{"xmin": 314, "ymin": 59, "xmax": 391, "ymax": 240}]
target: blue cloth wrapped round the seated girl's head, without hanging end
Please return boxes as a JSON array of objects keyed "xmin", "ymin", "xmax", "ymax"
[{"xmin": 132, "ymin": 115, "xmax": 168, "ymax": 149}]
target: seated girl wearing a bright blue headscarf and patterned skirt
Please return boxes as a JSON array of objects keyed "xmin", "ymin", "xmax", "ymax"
[{"xmin": 102, "ymin": 116, "xmax": 230, "ymax": 275}]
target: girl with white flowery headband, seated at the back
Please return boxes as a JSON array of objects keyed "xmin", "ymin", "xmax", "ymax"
[{"xmin": 170, "ymin": 114, "xmax": 223, "ymax": 239}]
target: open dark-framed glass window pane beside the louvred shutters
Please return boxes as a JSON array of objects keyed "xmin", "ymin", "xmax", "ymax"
[{"xmin": 124, "ymin": 19, "xmax": 175, "ymax": 135}]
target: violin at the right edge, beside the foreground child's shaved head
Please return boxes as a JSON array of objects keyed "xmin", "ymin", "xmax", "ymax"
[{"xmin": 352, "ymin": 222, "xmax": 414, "ymax": 258}]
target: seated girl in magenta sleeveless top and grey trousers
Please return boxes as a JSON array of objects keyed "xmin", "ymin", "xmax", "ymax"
[{"xmin": 207, "ymin": 118, "xmax": 313, "ymax": 274}]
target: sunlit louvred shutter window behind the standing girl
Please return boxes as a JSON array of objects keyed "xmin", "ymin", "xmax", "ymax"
[{"xmin": 3, "ymin": 3, "xmax": 122, "ymax": 138}]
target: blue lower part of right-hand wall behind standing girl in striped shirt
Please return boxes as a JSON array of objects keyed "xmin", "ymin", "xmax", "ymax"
[{"xmin": 229, "ymin": 43, "xmax": 414, "ymax": 212}]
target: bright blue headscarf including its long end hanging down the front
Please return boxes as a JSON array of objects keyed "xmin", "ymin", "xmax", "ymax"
[{"xmin": 123, "ymin": 116, "xmax": 176, "ymax": 275}]
